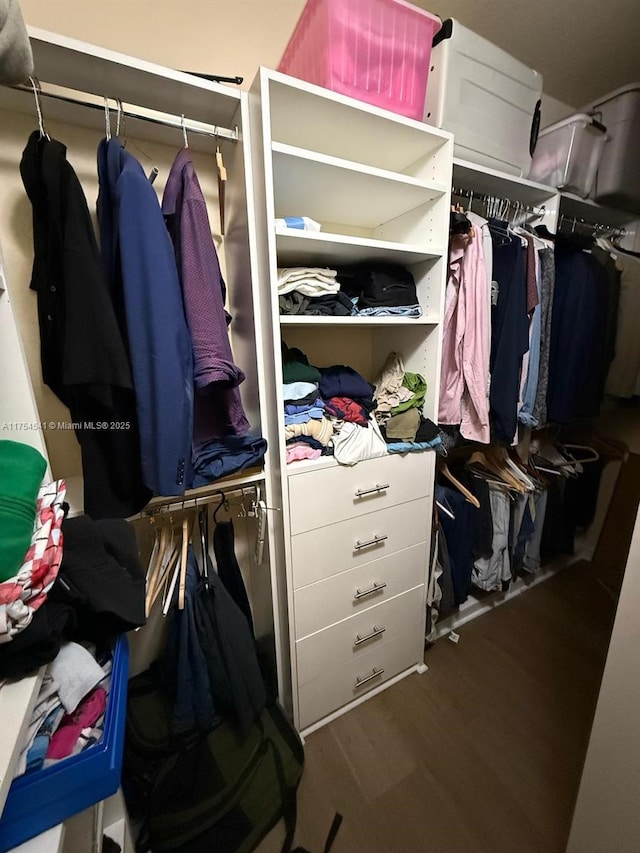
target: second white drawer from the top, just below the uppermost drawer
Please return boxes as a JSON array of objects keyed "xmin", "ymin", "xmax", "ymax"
[{"xmin": 291, "ymin": 498, "xmax": 431, "ymax": 589}]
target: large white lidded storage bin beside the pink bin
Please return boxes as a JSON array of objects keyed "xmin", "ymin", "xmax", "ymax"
[{"xmin": 424, "ymin": 20, "xmax": 542, "ymax": 177}]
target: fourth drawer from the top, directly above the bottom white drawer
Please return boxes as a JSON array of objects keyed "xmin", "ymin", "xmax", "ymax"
[{"xmin": 296, "ymin": 585, "xmax": 425, "ymax": 686}]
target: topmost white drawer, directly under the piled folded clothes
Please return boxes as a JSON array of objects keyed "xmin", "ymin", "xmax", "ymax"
[{"xmin": 288, "ymin": 452, "xmax": 435, "ymax": 535}]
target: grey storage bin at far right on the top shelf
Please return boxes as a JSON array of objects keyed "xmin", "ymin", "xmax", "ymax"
[{"xmin": 584, "ymin": 83, "xmax": 640, "ymax": 213}]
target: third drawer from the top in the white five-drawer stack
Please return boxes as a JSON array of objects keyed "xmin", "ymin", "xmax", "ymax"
[{"xmin": 294, "ymin": 542, "xmax": 428, "ymax": 639}]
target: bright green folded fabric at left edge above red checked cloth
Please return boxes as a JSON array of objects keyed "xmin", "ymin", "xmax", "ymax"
[{"xmin": 0, "ymin": 441, "xmax": 47, "ymax": 583}]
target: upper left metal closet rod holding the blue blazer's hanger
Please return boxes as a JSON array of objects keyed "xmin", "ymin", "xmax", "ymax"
[{"xmin": 10, "ymin": 83, "xmax": 238, "ymax": 142}]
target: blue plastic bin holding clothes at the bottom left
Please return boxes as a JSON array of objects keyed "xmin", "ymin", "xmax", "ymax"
[{"xmin": 0, "ymin": 635, "xmax": 129, "ymax": 853}]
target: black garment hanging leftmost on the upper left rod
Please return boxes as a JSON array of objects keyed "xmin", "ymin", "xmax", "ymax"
[{"xmin": 20, "ymin": 131, "xmax": 150, "ymax": 518}]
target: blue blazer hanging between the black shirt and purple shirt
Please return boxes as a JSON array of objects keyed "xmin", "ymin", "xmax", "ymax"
[{"xmin": 98, "ymin": 138, "xmax": 193, "ymax": 495}]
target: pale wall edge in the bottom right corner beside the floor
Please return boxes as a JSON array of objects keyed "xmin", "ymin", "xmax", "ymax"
[{"xmin": 567, "ymin": 512, "xmax": 640, "ymax": 853}]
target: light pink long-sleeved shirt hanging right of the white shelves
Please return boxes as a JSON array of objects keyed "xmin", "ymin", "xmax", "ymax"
[{"xmin": 438, "ymin": 226, "xmax": 490, "ymax": 444}]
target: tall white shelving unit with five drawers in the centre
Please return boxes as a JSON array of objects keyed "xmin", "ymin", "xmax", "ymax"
[{"xmin": 250, "ymin": 69, "xmax": 452, "ymax": 734}]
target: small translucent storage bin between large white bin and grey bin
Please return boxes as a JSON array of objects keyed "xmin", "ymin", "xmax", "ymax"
[{"xmin": 529, "ymin": 113, "xmax": 607, "ymax": 198}]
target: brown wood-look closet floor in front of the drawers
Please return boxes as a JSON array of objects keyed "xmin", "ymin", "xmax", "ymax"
[{"xmin": 268, "ymin": 563, "xmax": 615, "ymax": 853}]
